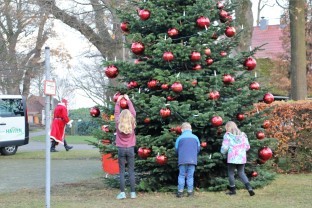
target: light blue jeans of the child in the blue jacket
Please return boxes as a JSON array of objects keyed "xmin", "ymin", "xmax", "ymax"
[{"xmin": 178, "ymin": 164, "xmax": 195, "ymax": 192}]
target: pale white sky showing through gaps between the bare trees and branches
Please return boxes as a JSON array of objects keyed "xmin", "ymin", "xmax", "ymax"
[{"xmin": 50, "ymin": 0, "xmax": 282, "ymax": 109}]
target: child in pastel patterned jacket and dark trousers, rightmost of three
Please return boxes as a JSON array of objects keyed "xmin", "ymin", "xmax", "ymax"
[{"xmin": 221, "ymin": 121, "xmax": 255, "ymax": 196}]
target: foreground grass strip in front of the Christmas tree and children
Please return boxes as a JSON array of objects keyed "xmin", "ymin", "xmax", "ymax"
[{"xmin": 0, "ymin": 174, "xmax": 312, "ymax": 208}]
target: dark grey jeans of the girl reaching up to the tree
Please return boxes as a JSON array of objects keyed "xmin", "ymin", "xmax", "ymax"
[{"xmin": 118, "ymin": 147, "xmax": 135, "ymax": 192}]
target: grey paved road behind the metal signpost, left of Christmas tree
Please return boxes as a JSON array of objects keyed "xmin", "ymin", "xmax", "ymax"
[{"xmin": 0, "ymin": 132, "xmax": 103, "ymax": 193}]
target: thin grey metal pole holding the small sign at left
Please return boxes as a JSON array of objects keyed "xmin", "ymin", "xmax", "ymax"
[{"xmin": 45, "ymin": 47, "xmax": 51, "ymax": 208}]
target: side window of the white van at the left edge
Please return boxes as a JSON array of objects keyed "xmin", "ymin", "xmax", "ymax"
[{"xmin": 0, "ymin": 98, "xmax": 24, "ymax": 117}]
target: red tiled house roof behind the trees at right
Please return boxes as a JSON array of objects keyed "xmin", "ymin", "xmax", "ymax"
[{"xmin": 251, "ymin": 25, "xmax": 285, "ymax": 59}]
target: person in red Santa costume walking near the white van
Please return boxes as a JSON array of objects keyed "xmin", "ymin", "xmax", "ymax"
[{"xmin": 50, "ymin": 102, "xmax": 73, "ymax": 152}]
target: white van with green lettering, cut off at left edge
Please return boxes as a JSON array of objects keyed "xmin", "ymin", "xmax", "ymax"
[{"xmin": 0, "ymin": 95, "xmax": 29, "ymax": 155}]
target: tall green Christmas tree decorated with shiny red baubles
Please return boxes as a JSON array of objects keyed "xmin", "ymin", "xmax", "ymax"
[{"xmin": 90, "ymin": 0, "xmax": 274, "ymax": 191}]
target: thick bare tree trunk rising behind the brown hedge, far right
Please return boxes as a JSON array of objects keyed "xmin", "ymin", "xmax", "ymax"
[{"xmin": 289, "ymin": 0, "xmax": 307, "ymax": 100}]
